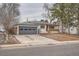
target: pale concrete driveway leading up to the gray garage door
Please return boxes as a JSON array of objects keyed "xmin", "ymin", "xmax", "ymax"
[{"xmin": 15, "ymin": 35, "xmax": 60, "ymax": 45}]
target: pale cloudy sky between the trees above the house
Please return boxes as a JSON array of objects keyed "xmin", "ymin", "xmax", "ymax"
[{"xmin": 20, "ymin": 3, "xmax": 44, "ymax": 21}]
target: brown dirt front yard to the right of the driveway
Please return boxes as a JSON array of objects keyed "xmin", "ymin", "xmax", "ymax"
[{"xmin": 40, "ymin": 33, "xmax": 79, "ymax": 41}]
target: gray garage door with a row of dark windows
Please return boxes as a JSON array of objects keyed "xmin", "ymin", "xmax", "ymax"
[{"xmin": 19, "ymin": 26, "xmax": 37, "ymax": 34}]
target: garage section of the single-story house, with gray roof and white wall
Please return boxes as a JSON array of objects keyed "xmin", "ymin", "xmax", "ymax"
[{"xmin": 14, "ymin": 21, "xmax": 48, "ymax": 34}]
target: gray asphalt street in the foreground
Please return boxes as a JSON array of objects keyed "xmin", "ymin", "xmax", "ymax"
[{"xmin": 0, "ymin": 43, "xmax": 79, "ymax": 56}]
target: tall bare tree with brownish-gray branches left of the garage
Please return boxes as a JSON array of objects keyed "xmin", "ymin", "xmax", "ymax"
[{"xmin": 0, "ymin": 3, "xmax": 19, "ymax": 39}]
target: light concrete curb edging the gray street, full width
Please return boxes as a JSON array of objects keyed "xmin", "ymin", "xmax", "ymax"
[{"xmin": 0, "ymin": 41, "xmax": 79, "ymax": 49}]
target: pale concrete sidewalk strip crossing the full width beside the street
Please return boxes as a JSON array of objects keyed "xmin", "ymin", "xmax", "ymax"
[{"xmin": 0, "ymin": 41, "xmax": 79, "ymax": 49}]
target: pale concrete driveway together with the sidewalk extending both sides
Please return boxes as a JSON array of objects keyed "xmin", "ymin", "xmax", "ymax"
[{"xmin": 0, "ymin": 35, "xmax": 79, "ymax": 48}]
